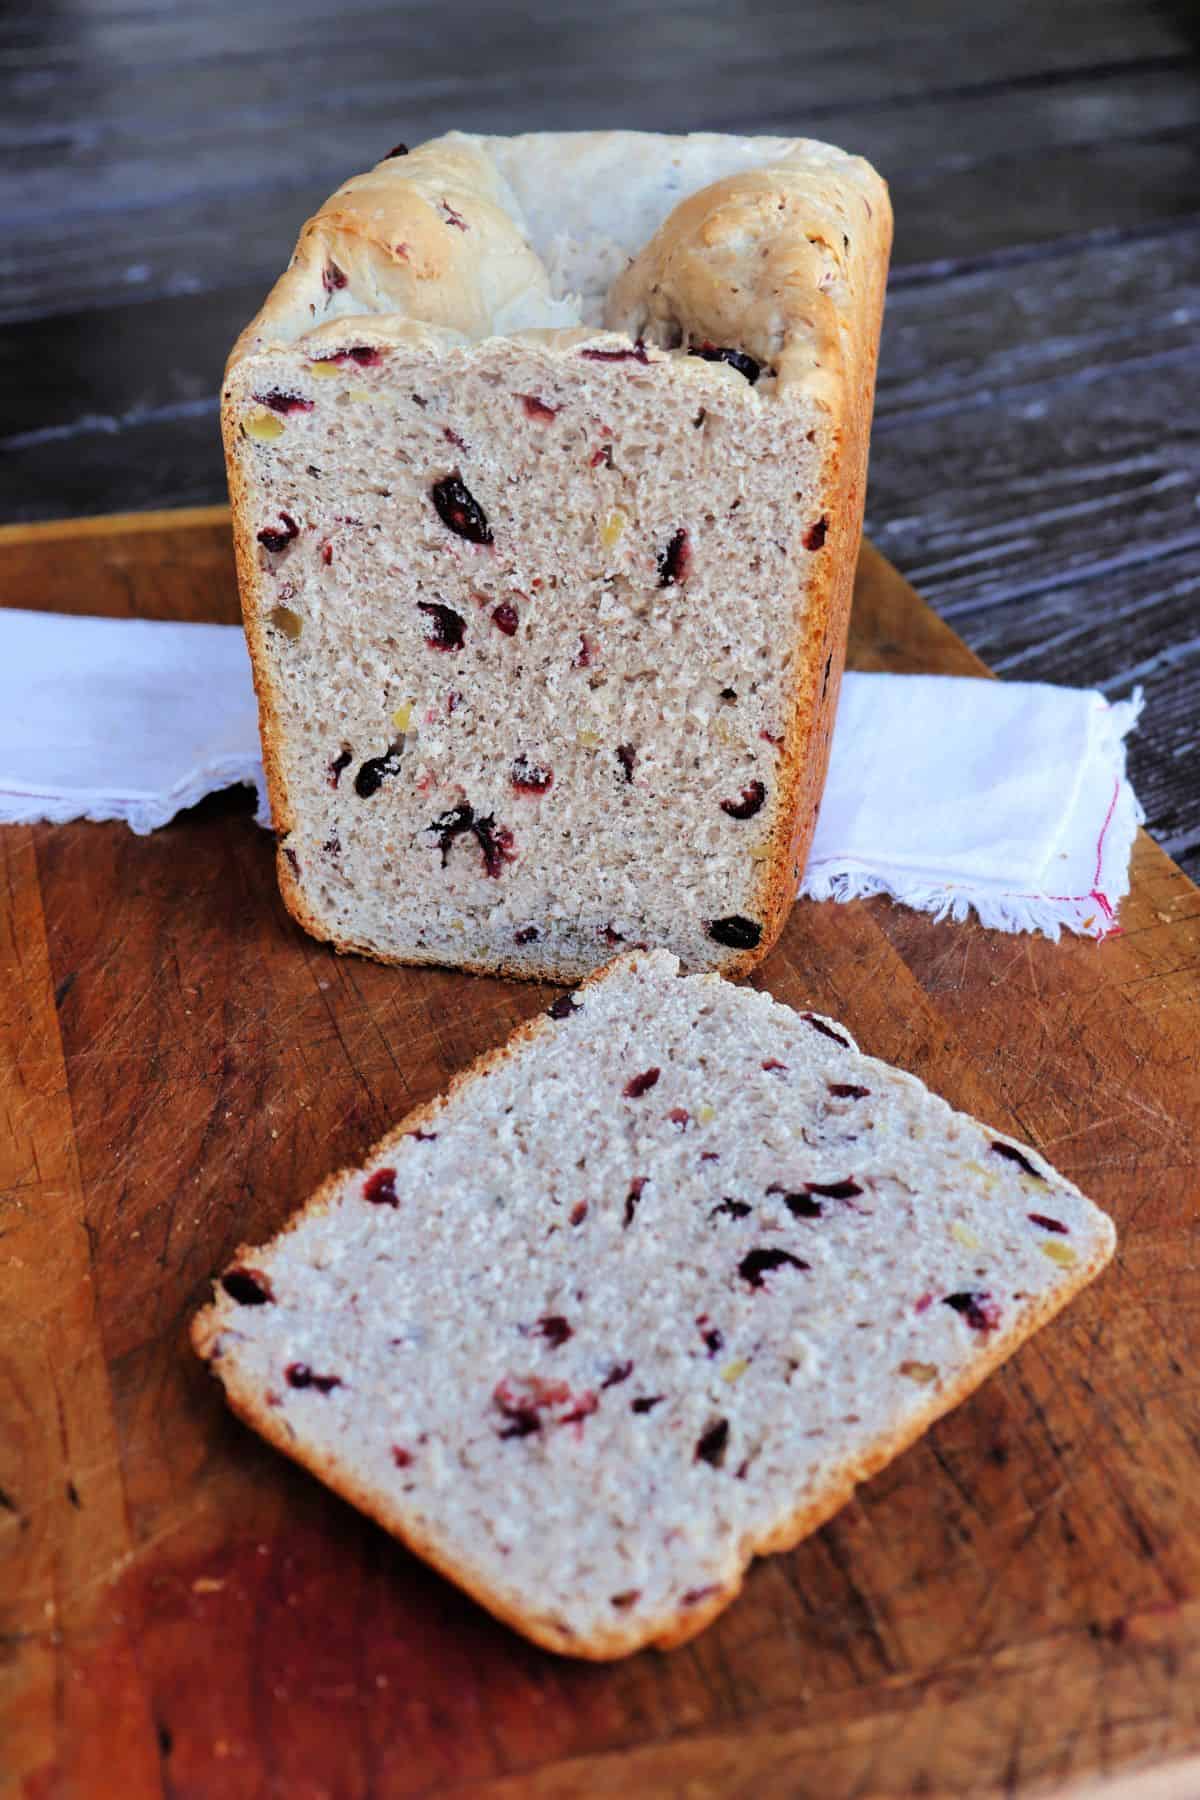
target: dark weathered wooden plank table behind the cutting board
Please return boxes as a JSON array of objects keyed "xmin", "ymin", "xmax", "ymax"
[{"xmin": 0, "ymin": 0, "xmax": 1200, "ymax": 875}]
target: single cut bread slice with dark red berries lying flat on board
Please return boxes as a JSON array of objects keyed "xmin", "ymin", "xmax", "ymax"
[{"xmin": 193, "ymin": 950, "xmax": 1114, "ymax": 1658}]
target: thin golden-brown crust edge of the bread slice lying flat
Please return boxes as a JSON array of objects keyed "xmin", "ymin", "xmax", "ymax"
[{"xmin": 191, "ymin": 952, "xmax": 1114, "ymax": 1661}]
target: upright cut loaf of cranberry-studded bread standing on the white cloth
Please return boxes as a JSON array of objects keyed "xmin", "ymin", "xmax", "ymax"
[{"xmin": 221, "ymin": 131, "xmax": 891, "ymax": 979}]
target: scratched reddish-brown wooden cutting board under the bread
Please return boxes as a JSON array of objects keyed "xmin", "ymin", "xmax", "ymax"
[{"xmin": 0, "ymin": 511, "xmax": 1200, "ymax": 1800}]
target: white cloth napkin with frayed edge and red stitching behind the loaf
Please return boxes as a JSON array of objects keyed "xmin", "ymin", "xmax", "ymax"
[{"xmin": 0, "ymin": 610, "xmax": 1142, "ymax": 938}]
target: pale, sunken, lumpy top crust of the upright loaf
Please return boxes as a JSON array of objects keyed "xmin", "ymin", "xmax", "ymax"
[{"xmin": 230, "ymin": 131, "xmax": 891, "ymax": 405}]
